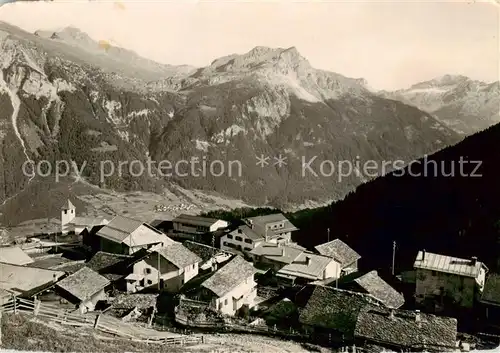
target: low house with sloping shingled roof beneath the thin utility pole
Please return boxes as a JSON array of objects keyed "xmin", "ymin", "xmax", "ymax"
[{"xmin": 329, "ymin": 270, "xmax": 405, "ymax": 309}]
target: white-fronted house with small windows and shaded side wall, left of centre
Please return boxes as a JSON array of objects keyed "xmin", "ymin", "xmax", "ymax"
[{"xmin": 125, "ymin": 242, "xmax": 202, "ymax": 293}]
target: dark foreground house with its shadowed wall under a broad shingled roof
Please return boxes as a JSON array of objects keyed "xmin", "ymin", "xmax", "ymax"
[{"xmin": 299, "ymin": 285, "xmax": 379, "ymax": 344}]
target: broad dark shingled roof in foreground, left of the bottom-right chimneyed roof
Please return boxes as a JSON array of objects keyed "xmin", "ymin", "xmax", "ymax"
[{"xmin": 299, "ymin": 285, "xmax": 378, "ymax": 337}]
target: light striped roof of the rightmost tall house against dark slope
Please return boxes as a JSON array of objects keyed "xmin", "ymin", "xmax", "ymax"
[{"xmin": 413, "ymin": 251, "xmax": 484, "ymax": 278}]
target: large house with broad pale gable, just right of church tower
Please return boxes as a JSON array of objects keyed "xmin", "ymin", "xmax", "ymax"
[{"xmin": 84, "ymin": 216, "xmax": 174, "ymax": 255}]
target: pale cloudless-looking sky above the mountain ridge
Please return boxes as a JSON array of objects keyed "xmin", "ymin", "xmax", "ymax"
[{"xmin": 0, "ymin": 0, "xmax": 500, "ymax": 89}]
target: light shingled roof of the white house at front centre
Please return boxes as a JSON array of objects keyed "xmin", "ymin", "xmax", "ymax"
[{"xmin": 201, "ymin": 256, "xmax": 255, "ymax": 297}]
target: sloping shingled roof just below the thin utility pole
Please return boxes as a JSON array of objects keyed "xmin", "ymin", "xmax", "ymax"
[{"xmin": 354, "ymin": 271, "xmax": 405, "ymax": 309}]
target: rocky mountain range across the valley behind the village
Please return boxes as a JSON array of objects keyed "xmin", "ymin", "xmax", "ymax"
[{"xmin": 0, "ymin": 23, "xmax": 498, "ymax": 219}]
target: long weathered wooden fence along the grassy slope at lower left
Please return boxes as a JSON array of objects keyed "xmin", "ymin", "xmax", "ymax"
[{"xmin": 0, "ymin": 297, "xmax": 204, "ymax": 346}]
